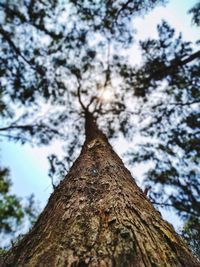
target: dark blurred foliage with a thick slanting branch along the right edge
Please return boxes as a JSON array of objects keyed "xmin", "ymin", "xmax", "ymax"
[{"xmin": 125, "ymin": 18, "xmax": 200, "ymax": 218}]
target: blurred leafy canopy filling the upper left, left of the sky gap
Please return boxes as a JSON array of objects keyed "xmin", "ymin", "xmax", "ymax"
[{"xmin": 0, "ymin": 0, "xmax": 165, "ymax": 171}]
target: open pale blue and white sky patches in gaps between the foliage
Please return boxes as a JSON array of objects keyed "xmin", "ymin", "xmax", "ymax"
[{"xmin": 0, "ymin": 0, "xmax": 200, "ymax": 230}]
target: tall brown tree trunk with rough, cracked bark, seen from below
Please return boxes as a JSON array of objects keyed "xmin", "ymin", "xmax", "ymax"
[{"xmin": 0, "ymin": 113, "xmax": 200, "ymax": 267}]
